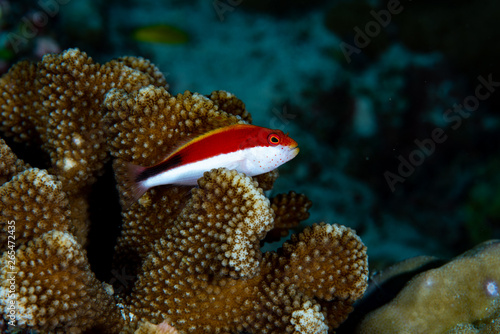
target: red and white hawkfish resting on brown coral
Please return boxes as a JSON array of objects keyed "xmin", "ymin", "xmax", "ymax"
[{"xmin": 126, "ymin": 124, "xmax": 299, "ymax": 203}]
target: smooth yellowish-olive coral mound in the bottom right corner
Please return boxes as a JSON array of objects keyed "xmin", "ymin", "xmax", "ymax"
[{"xmin": 359, "ymin": 241, "xmax": 500, "ymax": 334}]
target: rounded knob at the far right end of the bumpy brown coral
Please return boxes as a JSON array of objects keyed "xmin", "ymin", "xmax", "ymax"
[{"xmin": 283, "ymin": 224, "xmax": 368, "ymax": 301}]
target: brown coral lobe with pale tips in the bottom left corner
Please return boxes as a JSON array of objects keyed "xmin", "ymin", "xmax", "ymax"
[{"xmin": 0, "ymin": 231, "xmax": 123, "ymax": 333}]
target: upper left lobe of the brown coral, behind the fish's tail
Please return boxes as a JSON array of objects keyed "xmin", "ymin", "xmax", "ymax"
[{"xmin": 0, "ymin": 49, "xmax": 165, "ymax": 195}]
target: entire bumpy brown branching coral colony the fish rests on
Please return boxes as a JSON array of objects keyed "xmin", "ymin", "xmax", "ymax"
[{"xmin": 0, "ymin": 49, "xmax": 367, "ymax": 333}]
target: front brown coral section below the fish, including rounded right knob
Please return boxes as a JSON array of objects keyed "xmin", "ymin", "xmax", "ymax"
[{"xmin": 125, "ymin": 169, "xmax": 367, "ymax": 333}]
